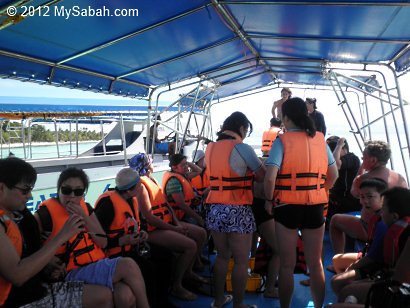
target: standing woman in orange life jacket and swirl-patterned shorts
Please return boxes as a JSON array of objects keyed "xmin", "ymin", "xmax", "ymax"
[{"xmin": 205, "ymin": 112, "xmax": 265, "ymax": 308}]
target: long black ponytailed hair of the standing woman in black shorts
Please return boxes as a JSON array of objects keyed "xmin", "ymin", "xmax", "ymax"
[{"xmin": 282, "ymin": 97, "xmax": 316, "ymax": 137}]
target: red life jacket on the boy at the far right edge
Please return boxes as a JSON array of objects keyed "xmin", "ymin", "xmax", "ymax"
[{"xmin": 383, "ymin": 216, "xmax": 410, "ymax": 267}]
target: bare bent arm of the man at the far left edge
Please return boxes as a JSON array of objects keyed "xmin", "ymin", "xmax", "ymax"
[{"xmin": 0, "ymin": 215, "xmax": 84, "ymax": 286}]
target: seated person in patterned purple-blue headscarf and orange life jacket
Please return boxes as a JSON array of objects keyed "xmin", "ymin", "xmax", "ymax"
[{"xmin": 129, "ymin": 153, "xmax": 209, "ymax": 301}]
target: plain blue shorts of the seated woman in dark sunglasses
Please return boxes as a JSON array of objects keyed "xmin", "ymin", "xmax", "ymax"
[{"xmin": 65, "ymin": 257, "xmax": 121, "ymax": 290}]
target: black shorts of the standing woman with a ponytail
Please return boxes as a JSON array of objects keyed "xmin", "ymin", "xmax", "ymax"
[{"xmin": 274, "ymin": 204, "xmax": 325, "ymax": 229}]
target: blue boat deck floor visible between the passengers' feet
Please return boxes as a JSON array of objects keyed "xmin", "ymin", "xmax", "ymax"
[{"xmin": 171, "ymin": 231, "xmax": 337, "ymax": 308}]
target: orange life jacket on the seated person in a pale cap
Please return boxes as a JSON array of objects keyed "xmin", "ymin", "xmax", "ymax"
[{"xmin": 95, "ymin": 190, "xmax": 140, "ymax": 257}]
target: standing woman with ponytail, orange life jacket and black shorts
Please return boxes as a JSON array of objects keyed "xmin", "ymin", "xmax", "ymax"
[{"xmin": 265, "ymin": 97, "xmax": 338, "ymax": 307}]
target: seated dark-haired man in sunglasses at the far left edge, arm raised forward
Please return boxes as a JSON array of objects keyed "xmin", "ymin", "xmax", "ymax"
[{"xmin": 0, "ymin": 158, "xmax": 113, "ymax": 307}]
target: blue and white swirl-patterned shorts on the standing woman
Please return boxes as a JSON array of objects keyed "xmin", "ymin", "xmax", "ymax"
[{"xmin": 206, "ymin": 204, "xmax": 256, "ymax": 234}]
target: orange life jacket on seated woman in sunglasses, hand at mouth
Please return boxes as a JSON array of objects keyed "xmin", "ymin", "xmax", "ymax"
[{"xmin": 40, "ymin": 198, "xmax": 105, "ymax": 271}]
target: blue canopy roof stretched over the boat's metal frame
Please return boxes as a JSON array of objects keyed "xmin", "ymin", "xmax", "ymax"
[{"xmin": 0, "ymin": 0, "xmax": 410, "ymax": 97}]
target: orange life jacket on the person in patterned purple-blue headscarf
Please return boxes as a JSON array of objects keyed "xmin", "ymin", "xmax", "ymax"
[{"xmin": 140, "ymin": 176, "xmax": 172, "ymax": 231}]
